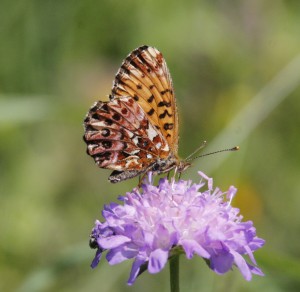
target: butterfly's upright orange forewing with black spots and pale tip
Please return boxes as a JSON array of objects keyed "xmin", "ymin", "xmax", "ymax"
[{"xmin": 112, "ymin": 46, "xmax": 178, "ymax": 157}]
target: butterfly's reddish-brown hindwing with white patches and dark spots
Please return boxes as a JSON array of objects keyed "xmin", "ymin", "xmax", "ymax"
[{"xmin": 84, "ymin": 96, "xmax": 170, "ymax": 182}]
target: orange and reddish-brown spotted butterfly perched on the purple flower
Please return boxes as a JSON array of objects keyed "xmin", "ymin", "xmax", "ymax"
[{"xmin": 84, "ymin": 46, "xmax": 190, "ymax": 183}]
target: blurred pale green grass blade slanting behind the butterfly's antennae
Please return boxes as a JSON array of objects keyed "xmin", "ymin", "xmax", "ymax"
[{"xmin": 195, "ymin": 54, "xmax": 300, "ymax": 173}]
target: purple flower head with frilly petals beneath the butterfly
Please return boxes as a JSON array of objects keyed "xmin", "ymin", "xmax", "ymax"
[{"xmin": 90, "ymin": 172, "xmax": 264, "ymax": 285}]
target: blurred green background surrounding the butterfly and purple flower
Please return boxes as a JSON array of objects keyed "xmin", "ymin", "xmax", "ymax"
[{"xmin": 0, "ymin": 0, "xmax": 300, "ymax": 292}]
